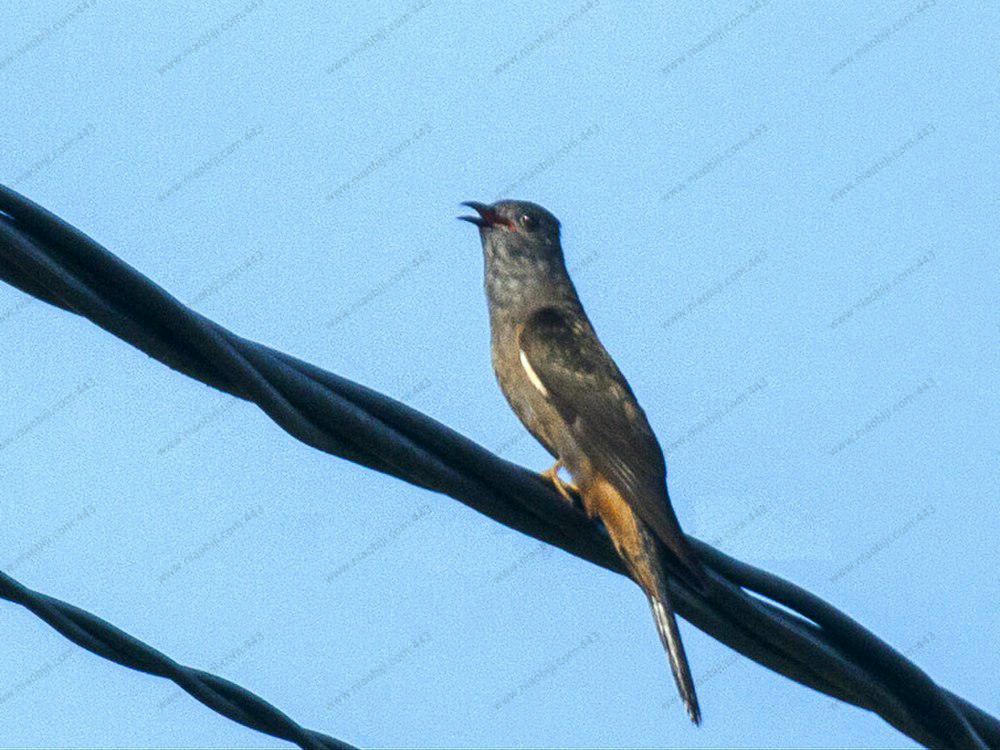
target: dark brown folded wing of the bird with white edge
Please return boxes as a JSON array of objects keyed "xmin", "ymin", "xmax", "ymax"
[{"xmin": 518, "ymin": 307, "xmax": 703, "ymax": 581}]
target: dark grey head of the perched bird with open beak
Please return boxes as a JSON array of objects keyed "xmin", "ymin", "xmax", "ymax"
[{"xmin": 458, "ymin": 200, "xmax": 562, "ymax": 264}]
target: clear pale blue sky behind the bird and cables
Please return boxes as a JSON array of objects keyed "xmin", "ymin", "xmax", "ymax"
[{"xmin": 0, "ymin": 0, "xmax": 1000, "ymax": 748}]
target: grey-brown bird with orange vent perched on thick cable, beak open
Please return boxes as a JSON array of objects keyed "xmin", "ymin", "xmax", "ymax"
[{"xmin": 458, "ymin": 200, "xmax": 708, "ymax": 725}]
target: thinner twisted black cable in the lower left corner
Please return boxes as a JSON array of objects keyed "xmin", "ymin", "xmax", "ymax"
[{"xmin": 0, "ymin": 571, "xmax": 353, "ymax": 750}]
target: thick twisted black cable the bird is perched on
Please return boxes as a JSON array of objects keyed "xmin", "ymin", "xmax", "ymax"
[{"xmin": 0, "ymin": 187, "xmax": 1000, "ymax": 748}]
